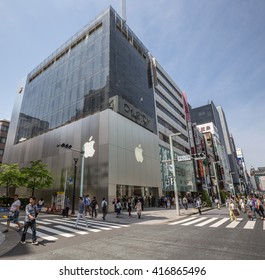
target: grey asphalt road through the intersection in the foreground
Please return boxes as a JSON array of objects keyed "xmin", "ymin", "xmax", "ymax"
[{"xmin": 1, "ymin": 208, "xmax": 265, "ymax": 260}]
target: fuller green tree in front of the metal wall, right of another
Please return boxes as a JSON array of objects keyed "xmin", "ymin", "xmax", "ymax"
[{"xmin": 21, "ymin": 160, "xmax": 53, "ymax": 196}]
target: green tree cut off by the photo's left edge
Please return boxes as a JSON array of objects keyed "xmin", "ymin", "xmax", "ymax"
[{"xmin": 0, "ymin": 163, "xmax": 22, "ymax": 197}]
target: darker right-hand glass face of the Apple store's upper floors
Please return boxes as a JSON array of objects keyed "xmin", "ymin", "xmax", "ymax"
[{"xmin": 110, "ymin": 12, "xmax": 156, "ymax": 133}]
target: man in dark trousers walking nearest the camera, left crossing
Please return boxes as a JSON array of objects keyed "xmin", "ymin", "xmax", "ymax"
[{"xmin": 20, "ymin": 196, "xmax": 39, "ymax": 245}]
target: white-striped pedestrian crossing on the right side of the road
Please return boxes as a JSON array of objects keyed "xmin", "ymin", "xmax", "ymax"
[{"xmin": 168, "ymin": 216, "xmax": 265, "ymax": 230}]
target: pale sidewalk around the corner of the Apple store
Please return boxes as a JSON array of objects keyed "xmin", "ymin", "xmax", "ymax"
[{"xmin": 0, "ymin": 207, "xmax": 210, "ymax": 257}]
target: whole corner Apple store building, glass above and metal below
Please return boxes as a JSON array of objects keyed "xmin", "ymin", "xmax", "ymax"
[{"xmin": 3, "ymin": 7, "xmax": 162, "ymax": 209}]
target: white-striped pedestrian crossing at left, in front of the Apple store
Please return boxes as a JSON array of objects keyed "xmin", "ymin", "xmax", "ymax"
[{"xmin": 1, "ymin": 217, "xmax": 130, "ymax": 241}]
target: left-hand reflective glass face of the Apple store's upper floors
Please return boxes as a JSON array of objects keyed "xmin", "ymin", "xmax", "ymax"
[{"xmin": 15, "ymin": 14, "xmax": 109, "ymax": 143}]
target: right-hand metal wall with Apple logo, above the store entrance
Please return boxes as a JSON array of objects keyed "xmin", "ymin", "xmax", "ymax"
[{"xmin": 106, "ymin": 111, "xmax": 161, "ymax": 187}]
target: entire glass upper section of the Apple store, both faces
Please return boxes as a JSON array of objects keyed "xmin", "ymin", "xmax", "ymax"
[{"xmin": 15, "ymin": 9, "xmax": 156, "ymax": 143}]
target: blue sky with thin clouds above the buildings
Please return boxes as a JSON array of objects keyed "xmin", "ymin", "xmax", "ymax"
[{"xmin": 0, "ymin": 0, "xmax": 265, "ymax": 170}]
